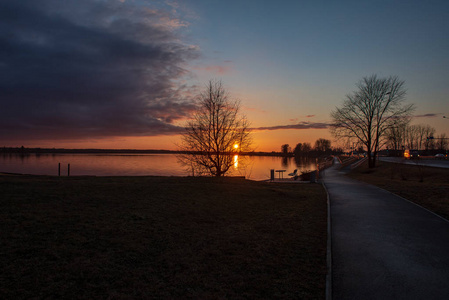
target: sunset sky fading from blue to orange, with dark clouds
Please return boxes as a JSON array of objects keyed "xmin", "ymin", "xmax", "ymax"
[{"xmin": 0, "ymin": 0, "xmax": 449, "ymax": 151}]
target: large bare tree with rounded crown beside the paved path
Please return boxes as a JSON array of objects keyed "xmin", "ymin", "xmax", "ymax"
[{"xmin": 331, "ymin": 75, "xmax": 414, "ymax": 168}]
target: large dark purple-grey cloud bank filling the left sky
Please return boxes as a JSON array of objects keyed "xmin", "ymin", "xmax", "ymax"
[{"xmin": 0, "ymin": 0, "xmax": 198, "ymax": 139}]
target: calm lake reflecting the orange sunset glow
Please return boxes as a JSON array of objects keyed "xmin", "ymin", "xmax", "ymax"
[{"xmin": 0, "ymin": 153, "xmax": 315, "ymax": 180}]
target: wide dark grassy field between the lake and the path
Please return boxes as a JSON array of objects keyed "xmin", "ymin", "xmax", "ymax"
[{"xmin": 0, "ymin": 176, "xmax": 327, "ymax": 299}]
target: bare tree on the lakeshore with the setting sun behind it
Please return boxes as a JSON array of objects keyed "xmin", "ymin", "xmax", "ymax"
[{"xmin": 179, "ymin": 80, "xmax": 251, "ymax": 176}]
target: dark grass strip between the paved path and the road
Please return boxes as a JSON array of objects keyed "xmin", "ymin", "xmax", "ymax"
[{"xmin": 348, "ymin": 161, "xmax": 449, "ymax": 220}]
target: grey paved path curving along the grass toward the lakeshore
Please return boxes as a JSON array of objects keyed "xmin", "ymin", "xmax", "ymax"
[{"xmin": 324, "ymin": 159, "xmax": 449, "ymax": 300}]
